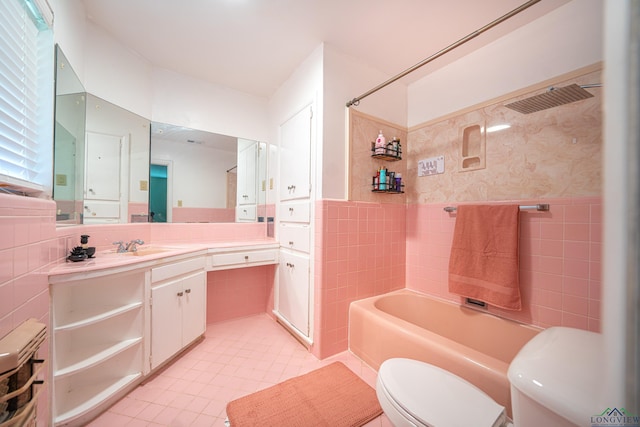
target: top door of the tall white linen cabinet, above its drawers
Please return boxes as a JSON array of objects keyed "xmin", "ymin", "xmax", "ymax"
[{"xmin": 280, "ymin": 106, "xmax": 312, "ymax": 200}]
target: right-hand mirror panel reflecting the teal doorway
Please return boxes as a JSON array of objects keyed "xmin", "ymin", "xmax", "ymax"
[{"xmin": 149, "ymin": 122, "xmax": 270, "ymax": 222}]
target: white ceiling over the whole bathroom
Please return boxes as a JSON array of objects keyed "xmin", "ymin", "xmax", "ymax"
[{"xmin": 82, "ymin": 0, "xmax": 569, "ymax": 97}]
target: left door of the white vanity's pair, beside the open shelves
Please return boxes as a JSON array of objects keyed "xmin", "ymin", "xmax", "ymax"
[{"xmin": 151, "ymin": 279, "xmax": 184, "ymax": 369}]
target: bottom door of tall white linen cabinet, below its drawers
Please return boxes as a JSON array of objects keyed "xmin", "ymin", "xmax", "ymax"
[{"xmin": 278, "ymin": 251, "xmax": 309, "ymax": 336}]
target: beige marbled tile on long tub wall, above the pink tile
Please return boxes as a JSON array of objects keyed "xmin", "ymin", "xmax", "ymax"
[{"xmin": 404, "ymin": 71, "xmax": 602, "ymax": 205}]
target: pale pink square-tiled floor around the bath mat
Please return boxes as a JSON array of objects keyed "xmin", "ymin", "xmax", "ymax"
[{"xmin": 89, "ymin": 314, "xmax": 392, "ymax": 427}]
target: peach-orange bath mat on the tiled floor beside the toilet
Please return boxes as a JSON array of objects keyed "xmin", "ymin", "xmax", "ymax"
[{"xmin": 227, "ymin": 362, "xmax": 382, "ymax": 427}]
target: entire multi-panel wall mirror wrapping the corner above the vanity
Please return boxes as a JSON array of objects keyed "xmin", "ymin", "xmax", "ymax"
[{"xmin": 53, "ymin": 46, "xmax": 273, "ymax": 225}]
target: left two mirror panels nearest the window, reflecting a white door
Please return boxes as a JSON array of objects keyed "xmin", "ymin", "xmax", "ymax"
[{"xmin": 53, "ymin": 47, "xmax": 150, "ymax": 225}]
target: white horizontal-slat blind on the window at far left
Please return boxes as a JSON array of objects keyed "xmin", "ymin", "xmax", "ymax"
[{"xmin": 0, "ymin": 0, "xmax": 53, "ymax": 196}]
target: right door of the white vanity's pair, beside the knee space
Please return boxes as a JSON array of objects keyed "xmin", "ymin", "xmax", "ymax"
[{"xmin": 180, "ymin": 271, "xmax": 207, "ymax": 347}]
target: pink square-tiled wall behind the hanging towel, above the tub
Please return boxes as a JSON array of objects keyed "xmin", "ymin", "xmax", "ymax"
[{"xmin": 406, "ymin": 197, "xmax": 602, "ymax": 332}]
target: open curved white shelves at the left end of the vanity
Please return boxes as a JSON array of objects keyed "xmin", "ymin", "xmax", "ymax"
[{"xmin": 50, "ymin": 270, "xmax": 145, "ymax": 425}]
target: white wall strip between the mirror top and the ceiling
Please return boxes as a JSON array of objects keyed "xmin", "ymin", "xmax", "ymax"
[{"xmin": 51, "ymin": 0, "xmax": 268, "ymax": 141}]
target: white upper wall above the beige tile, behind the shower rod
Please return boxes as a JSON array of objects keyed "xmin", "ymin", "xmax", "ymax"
[{"xmin": 407, "ymin": 0, "xmax": 603, "ymax": 127}]
